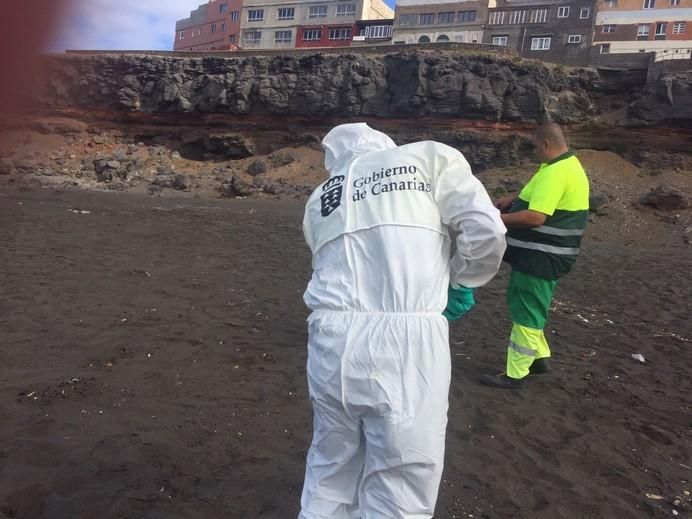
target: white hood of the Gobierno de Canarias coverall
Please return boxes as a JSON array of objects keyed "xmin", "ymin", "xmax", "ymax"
[{"xmin": 322, "ymin": 123, "xmax": 397, "ymax": 176}]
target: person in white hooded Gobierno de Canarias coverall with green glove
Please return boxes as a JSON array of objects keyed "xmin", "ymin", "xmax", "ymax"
[{"xmin": 299, "ymin": 123, "xmax": 505, "ymax": 519}]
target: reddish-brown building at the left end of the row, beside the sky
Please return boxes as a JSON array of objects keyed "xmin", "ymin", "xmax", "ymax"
[{"xmin": 173, "ymin": 0, "xmax": 243, "ymax": 51}]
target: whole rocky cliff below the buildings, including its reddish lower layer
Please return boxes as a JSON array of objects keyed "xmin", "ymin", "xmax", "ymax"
[{"xmin": 0, "ymin": 49, "xmax": 692, "ymax": 193}]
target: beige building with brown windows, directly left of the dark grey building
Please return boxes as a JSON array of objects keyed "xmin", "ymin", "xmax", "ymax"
[{"xmin": 392, "ymin": 0, "xmax": 488, "ymax": 44}]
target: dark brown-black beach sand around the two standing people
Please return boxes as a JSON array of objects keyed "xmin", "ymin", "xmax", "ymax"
[{"xmin": 0, "ymin": 188, "xmax": 692, "ymax": 519}]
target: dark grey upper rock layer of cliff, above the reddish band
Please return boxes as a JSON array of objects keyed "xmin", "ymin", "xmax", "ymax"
[{"xmin": 42, "ymin": 51, "xmax": 616, "ymax": 123}]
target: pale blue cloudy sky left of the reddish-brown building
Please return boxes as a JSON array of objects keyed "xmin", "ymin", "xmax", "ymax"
[{"xmin": 50, "ymin": 0, "xmax": 394, "ymax": 52}]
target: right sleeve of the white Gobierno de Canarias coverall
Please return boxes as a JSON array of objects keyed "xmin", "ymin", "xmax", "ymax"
[{"xmin": 435, "ymin": 145, "xmax": 507, "ymax": 288}]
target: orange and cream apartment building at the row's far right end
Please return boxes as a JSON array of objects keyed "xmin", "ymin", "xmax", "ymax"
[{"xmin": 593, "ymin": 0, "xmax": 692, "ymax": 53}]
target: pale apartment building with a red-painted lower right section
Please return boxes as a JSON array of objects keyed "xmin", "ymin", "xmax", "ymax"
[{"xmin": 240, "ymin": 0, "xmax": 394, "ymax": 49}]
